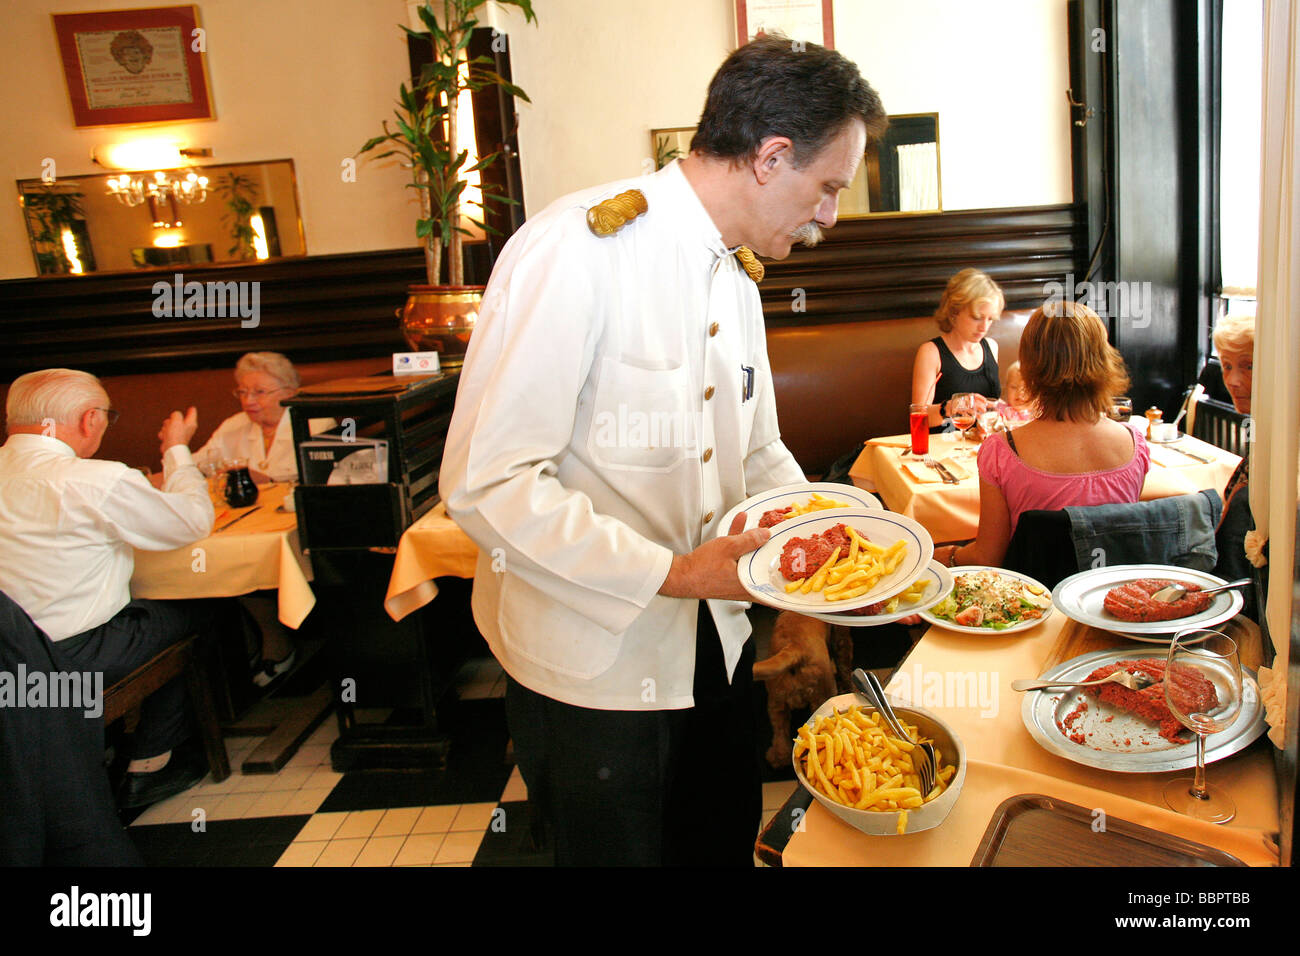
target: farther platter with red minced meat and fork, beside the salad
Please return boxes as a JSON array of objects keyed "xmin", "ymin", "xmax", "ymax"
[{"xmin": 1052, "ymin": 564, "xmax": 1243, "ymax": 644}]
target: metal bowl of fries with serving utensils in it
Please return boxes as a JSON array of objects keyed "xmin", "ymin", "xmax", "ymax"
[{"xmin": 793, "ymin": 693, "xmax": 966, "ymax": 836}]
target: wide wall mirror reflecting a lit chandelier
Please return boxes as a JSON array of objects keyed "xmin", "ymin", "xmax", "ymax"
[{"xmin": 18, "ymin": 159, "xmax": 307, "ymax": 276}]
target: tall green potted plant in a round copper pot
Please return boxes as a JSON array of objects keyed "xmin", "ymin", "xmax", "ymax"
[{"xmin": 358, "ymin": 0, "xmax": 537, "ymax": 368}]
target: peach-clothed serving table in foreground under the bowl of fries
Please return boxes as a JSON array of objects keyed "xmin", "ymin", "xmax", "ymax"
[{"xmin": 759, "ymin": 611, "xmax": 1278, "ymax": 866}]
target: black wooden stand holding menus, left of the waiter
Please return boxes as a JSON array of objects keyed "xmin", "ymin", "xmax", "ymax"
[{"xmin": 285, "ymin": 375, "xmax": 459, "ymax": 773}]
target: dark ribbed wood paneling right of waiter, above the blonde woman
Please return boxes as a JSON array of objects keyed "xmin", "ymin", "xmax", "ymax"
[{"xmin": 759, "ymin": 206, "xmax": 1086, "ymax": 325}]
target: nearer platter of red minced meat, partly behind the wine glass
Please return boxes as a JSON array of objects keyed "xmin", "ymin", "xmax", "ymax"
[{"xmin": 1021, "ymin": 646, "xmax": 1268, "ymax": 774}]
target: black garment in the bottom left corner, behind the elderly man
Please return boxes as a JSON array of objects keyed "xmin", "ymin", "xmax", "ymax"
[{"xmin": 0, "ymin": 594, "xmax": 140, "ymax": 866}]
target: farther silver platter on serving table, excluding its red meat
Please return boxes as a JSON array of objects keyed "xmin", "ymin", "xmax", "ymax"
[{"xmin": 1052, "ymin": 564, "xmax": 1244, "ymax": 644}]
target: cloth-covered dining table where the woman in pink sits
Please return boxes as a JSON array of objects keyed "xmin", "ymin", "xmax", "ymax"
[{"xmin": 849, "ymin": 433, "xmax": 1242, "ymax": 542}]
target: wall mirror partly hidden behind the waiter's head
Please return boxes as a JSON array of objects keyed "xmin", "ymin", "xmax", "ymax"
[{"xmin": 650, "ymin": 113, "xmax": 944, "ymax": 219}]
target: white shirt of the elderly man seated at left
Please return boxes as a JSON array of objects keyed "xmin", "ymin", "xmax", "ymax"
[{"xmin": 0, "ymin": 434, "xmax": 212, "ymax": 641}]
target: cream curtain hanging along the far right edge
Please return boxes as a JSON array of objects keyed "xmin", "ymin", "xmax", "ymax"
[{"xmin": 1251, "ymin": 0, "xmax": 1300, "ymax": 747}]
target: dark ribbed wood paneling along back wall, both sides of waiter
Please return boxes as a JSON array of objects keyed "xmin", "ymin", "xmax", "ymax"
[{"xmin": 0, "ymin": 206, "xmax": 1083, "ymax": 381}]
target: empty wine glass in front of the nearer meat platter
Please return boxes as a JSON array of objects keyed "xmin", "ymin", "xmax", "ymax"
[{"xmin": 1165, "ymin": 627, "xmax": 1242, "ymax": 823}]
